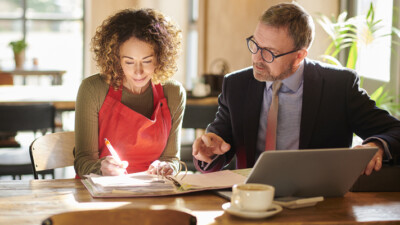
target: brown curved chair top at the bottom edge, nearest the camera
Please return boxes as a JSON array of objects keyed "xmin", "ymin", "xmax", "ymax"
[{"xmin": 42, "ymin": 208, "xmax": 197, "ymax": 225}]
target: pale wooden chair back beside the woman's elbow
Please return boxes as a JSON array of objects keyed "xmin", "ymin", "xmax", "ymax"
[{"xmin": 29, "ymin": 131, "xmax": 75, "ymax": 179}]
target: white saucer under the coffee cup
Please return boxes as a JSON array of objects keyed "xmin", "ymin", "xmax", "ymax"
[{"xmin": 222, "ymin": 202, "xmax": 282, "ymax": 219}]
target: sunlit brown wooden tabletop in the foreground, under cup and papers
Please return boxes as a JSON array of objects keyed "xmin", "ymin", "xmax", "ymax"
[{"xmin": 0, "ymin": 179, "xmax": 400, "ymax": 225}]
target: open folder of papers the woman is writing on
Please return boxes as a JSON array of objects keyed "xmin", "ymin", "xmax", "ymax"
[{"xmin": 82, "ymin": 170, "xmax": 246, "ymax": 197}]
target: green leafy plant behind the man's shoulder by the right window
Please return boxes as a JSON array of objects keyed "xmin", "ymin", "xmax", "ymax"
[{"xmin": 317, "ymin": 3, "xmax": 400, "ymax": 117}]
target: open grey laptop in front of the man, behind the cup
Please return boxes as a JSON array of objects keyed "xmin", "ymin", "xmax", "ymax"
[{"xmin": 218, "ymin": 148, "xmax": 378, "ymax": 199}]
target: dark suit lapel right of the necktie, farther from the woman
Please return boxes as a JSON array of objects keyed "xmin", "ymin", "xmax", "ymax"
[{"xmin": 299, "ymin": 60, "xmax": 323, "ymax": 149}]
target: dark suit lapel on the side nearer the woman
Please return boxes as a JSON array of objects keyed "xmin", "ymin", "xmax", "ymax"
[{"xmin": 244, "ymin": 73, "xmax": 265, "ymax": 166}]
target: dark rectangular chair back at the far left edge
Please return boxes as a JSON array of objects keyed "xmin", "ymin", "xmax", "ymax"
[{"xmin": 0, "ymin": 103, "xmax": 55, "ymax": 132}]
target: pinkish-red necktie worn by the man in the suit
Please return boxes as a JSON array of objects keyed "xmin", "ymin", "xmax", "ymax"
[{"xmin": 265, "ymin": 80, "xmax": 282, "ymax": 151}]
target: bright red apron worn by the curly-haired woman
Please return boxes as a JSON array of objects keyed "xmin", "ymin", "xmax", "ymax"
[{"xmin": 99, "ymin": 83, "xmax": 171, "ymax": 173}]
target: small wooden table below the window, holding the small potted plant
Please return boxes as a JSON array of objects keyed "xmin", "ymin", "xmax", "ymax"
[{"xmin": 0, "ymin": 66, "xmax": 66, "ymax": 85}]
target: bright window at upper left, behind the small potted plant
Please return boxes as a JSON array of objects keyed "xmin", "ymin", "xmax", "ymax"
[{"xmin": 0, "ymin": 0, "xmax": 84, "ymax": 85}]
